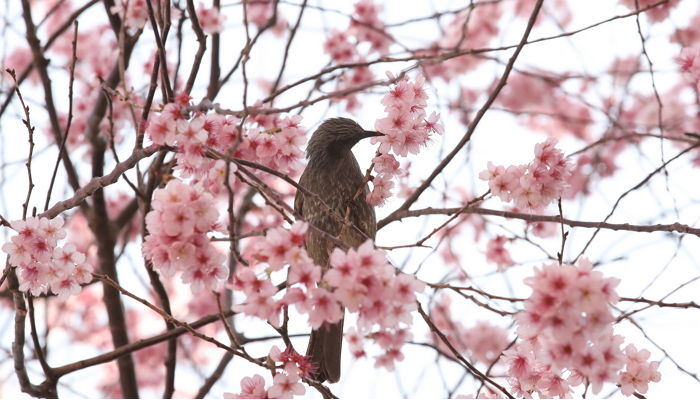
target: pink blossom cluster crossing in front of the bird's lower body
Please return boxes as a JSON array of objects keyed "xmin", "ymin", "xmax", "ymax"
[{"xmin": 231, "ymin": 230, "xmax": 424, "ymax": 368}]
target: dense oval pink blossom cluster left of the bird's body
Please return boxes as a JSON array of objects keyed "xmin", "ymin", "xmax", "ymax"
[{"xmin": 138, "ymin": 179, "xmax": 223, "ymax": 293}]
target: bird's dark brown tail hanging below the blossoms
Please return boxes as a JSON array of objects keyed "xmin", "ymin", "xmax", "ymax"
[{"xmin": 306, "ymin": 318, "xmax": 345, "ymax": 383}]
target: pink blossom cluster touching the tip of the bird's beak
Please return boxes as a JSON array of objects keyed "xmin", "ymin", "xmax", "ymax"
[{"xmin": 367, "ymin": 74, "xmax": 443, "ymax": 206}]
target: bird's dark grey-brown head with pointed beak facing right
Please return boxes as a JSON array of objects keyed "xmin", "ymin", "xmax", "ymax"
[{"xmin": 306, "ymin": 117, "xmax": 383, "ymax": 161}]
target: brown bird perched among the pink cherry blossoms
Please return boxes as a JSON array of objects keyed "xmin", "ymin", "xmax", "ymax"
[{"xmin": 294, "ymin": 117, "xmax": 383, "ymax": 383}]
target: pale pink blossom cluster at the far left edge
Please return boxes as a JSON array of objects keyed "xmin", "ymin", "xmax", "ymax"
[{"xmin": 2, "ymin": 217, "xmax": 92, "ymax": 300}]
